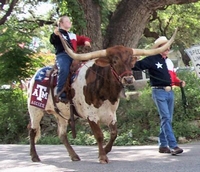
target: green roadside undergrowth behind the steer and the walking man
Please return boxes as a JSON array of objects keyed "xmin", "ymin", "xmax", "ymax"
[{"xmin": 0, "ymin": 71, "xmax": 200, "ymax": 145}]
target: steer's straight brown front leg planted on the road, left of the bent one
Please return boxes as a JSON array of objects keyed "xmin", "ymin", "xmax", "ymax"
[{"xmin": 88, "ymin": 119, "xmax": 109, "ymax": 164}]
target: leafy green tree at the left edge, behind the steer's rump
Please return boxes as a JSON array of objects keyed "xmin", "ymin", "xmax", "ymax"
[{"xmin": 0, "ymin": 19, "xmax": 46, "ymax": 85}]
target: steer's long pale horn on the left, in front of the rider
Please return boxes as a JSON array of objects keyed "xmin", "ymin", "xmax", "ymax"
[{"xmin": 58, "ymin": 32, "xmax": 106, "ymax": 61}]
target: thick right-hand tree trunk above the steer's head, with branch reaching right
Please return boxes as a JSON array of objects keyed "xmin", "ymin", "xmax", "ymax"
[{"xmin": 104, "ymin": 0, "xmax": 198, "ymax": 48}]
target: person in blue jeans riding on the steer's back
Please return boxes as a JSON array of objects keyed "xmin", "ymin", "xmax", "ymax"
[{"xmin": 50, "ymin": 16, "xmax": 91, "ymax": 103}]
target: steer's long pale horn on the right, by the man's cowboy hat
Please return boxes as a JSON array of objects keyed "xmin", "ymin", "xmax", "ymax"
[{"xmin": 133, "ymin": 29, "xmax": 178, "ymax": 56}]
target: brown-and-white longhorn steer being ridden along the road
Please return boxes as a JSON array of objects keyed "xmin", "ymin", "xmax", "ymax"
[{"xmin": 28, "ymin": 29, "xmax": 175, "ymax": 163}]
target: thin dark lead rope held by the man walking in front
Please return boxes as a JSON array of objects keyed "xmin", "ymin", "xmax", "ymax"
[{"xmin": 135, "ymin": 66, "xmax": 188, "ymax": 114}]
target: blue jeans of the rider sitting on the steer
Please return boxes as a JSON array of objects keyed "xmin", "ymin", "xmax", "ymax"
[{"xmin": 56, "ymin": 52, "xmax": 73, "ymax": 93}]
